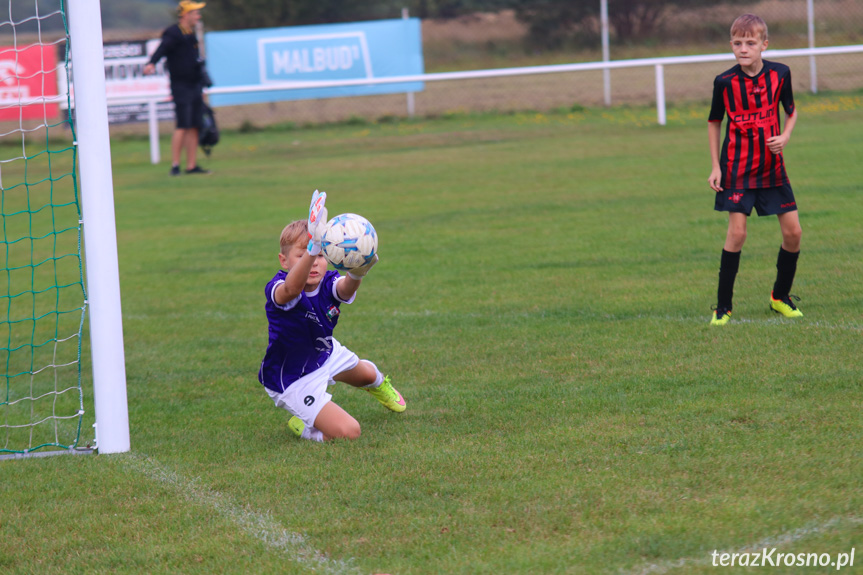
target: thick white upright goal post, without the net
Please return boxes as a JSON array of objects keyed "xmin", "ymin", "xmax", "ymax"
[{"xmin": 68, "ymin": 0, "xmax": 130, "ymax": 453}]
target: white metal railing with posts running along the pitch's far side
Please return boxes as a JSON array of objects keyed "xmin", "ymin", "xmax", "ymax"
[{"xmin": 98, "ymin": 45, "xmax": 863, "ymax": 164}]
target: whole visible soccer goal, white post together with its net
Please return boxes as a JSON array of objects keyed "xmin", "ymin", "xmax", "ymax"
[{"xmin": 0, "ymin": 0, "xmax": 130, "ymax": 459}]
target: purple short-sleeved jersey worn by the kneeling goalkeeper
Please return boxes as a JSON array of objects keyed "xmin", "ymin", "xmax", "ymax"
[{"xmin": 258, "ymin": 270, "xmax": 353, "ymax": 393}]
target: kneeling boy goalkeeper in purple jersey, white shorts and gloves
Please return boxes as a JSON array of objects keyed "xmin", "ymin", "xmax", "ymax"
[{"xmin": 258, "ymin": 190, "xmax": 406, "ymax": 441}]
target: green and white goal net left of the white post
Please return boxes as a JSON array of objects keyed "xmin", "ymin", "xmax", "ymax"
[{"xmin": 0, "ymin": 2, "xmax": 87, "ymax": 454}]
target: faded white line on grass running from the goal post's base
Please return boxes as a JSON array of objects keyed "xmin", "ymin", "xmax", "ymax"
[{"xmin": 115, "ymin": 453, "xmax": 358, "ymax": 575}]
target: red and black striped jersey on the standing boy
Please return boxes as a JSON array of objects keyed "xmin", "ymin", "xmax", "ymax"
[{"xmin": 708, "ymin": 60, "xmax": 794, "ymax": 190}]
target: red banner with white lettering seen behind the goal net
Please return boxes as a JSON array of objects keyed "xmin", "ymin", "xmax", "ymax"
[{"xmin": 0, "ymin": 44, "xmax": 59, "ymax": 121}]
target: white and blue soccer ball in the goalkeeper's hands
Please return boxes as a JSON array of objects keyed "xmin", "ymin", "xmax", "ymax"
[{"xmin": 321, "ymin": 214, "xmax": 378, "ymax": 271}]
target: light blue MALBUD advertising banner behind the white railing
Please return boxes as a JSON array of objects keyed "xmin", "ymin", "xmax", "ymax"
[{"xmin": 204, "ymin": 18, "xmax": 424, "ymax": 106}]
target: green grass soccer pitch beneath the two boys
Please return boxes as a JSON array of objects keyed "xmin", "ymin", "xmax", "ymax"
[{"xmin": 5, "ymin": 95, "xmax": 863, "ymax": 575}]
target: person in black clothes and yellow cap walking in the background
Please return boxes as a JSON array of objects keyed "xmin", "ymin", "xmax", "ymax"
[{"xmin": 144, "ymin": 0, "xmax": 209, "ymax": 176}]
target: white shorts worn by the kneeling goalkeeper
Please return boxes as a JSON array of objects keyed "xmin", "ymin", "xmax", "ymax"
[{"xmin": 264, "ymin": 338, "xmax": 360, "ymax": 427}]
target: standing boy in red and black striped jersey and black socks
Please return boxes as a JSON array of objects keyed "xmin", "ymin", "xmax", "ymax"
[{"xmin": 708, "ymin": 14, "xmax": 803, "ymax": 325}]
